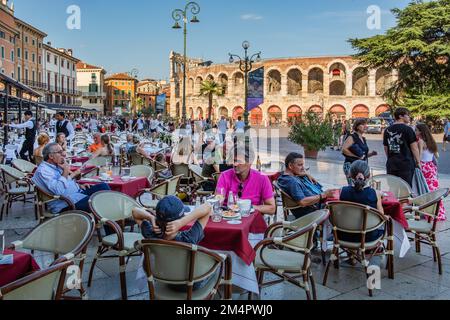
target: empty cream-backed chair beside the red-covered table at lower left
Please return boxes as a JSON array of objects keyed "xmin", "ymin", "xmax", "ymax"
[{"xmin": 10, "ymin": 211, "xmax": 95, "ymax": 298}]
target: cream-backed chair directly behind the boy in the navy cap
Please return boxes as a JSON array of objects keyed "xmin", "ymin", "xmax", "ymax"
[{"xmin": 135, "ymin": 240, "xmax": 232, "ymax": 300}]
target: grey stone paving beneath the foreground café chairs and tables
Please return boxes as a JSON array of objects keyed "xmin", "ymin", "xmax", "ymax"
[{"xmin": 0, "ymin": 161, "xmax": 450, "ymax": 300}]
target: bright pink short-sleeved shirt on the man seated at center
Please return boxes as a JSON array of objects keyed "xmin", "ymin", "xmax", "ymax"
[{"xmin": 216, "ymin": 169, "xmax": 274, "ymax": 206}]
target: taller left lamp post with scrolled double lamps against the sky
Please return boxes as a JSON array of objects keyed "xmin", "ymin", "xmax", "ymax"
[{"xmin": 172, "ymin": 2, "xmax": 200, "ymax": 122}]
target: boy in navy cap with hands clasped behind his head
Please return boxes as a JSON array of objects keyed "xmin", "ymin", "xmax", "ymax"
[{"xmin": 133, "ymin": 196, "xmax": 212, "ymax": 244}]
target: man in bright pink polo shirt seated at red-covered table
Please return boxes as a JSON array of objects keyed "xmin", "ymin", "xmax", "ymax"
[{"xmin": 216, "ymin": 146, "xmax": 276, "ymax": 215}]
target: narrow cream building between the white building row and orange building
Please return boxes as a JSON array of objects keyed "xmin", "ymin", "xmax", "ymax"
[{"xmin": 76, "ymin": 61, "xmax": 106, "ymax": 114}]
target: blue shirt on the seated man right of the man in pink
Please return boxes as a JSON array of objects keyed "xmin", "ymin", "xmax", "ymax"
[{"xmin": 278, "ymin": 174, "xmax": 323, "ymax": 219}]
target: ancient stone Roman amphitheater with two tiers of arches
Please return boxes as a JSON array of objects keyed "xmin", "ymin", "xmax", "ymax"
[{"xmin": 170, "ymin": 52, "xmax": 398, "ymax": 125}]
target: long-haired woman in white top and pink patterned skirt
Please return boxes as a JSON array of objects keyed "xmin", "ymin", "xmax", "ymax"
[{"xmin": 416, "ymin": 123, "xmax": 446, "ymax": 221}]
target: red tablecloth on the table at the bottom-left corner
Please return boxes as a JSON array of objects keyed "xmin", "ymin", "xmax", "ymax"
[{"xmin": 0, "ymin": 250, "xmax": 40, "ymax": 287}]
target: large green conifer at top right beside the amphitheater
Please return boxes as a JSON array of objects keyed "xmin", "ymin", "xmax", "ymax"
[{"xmin": 349, "ymin": 0, "xmax": 450, "ymax": 118}]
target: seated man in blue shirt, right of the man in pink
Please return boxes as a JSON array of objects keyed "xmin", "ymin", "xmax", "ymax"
[{"xmin": 278, "ymin": 153, "xmax": 335, "ymax": 219}]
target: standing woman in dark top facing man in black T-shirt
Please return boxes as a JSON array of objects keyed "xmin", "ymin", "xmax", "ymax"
[{"xmin": 342, "ymin": 119, "xmax": 378, "ymax": 186}]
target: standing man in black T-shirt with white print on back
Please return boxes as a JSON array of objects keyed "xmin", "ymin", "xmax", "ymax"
[{"xmin": 383, "ymin": 108, "xmax": 421, "ymax": 187}]
